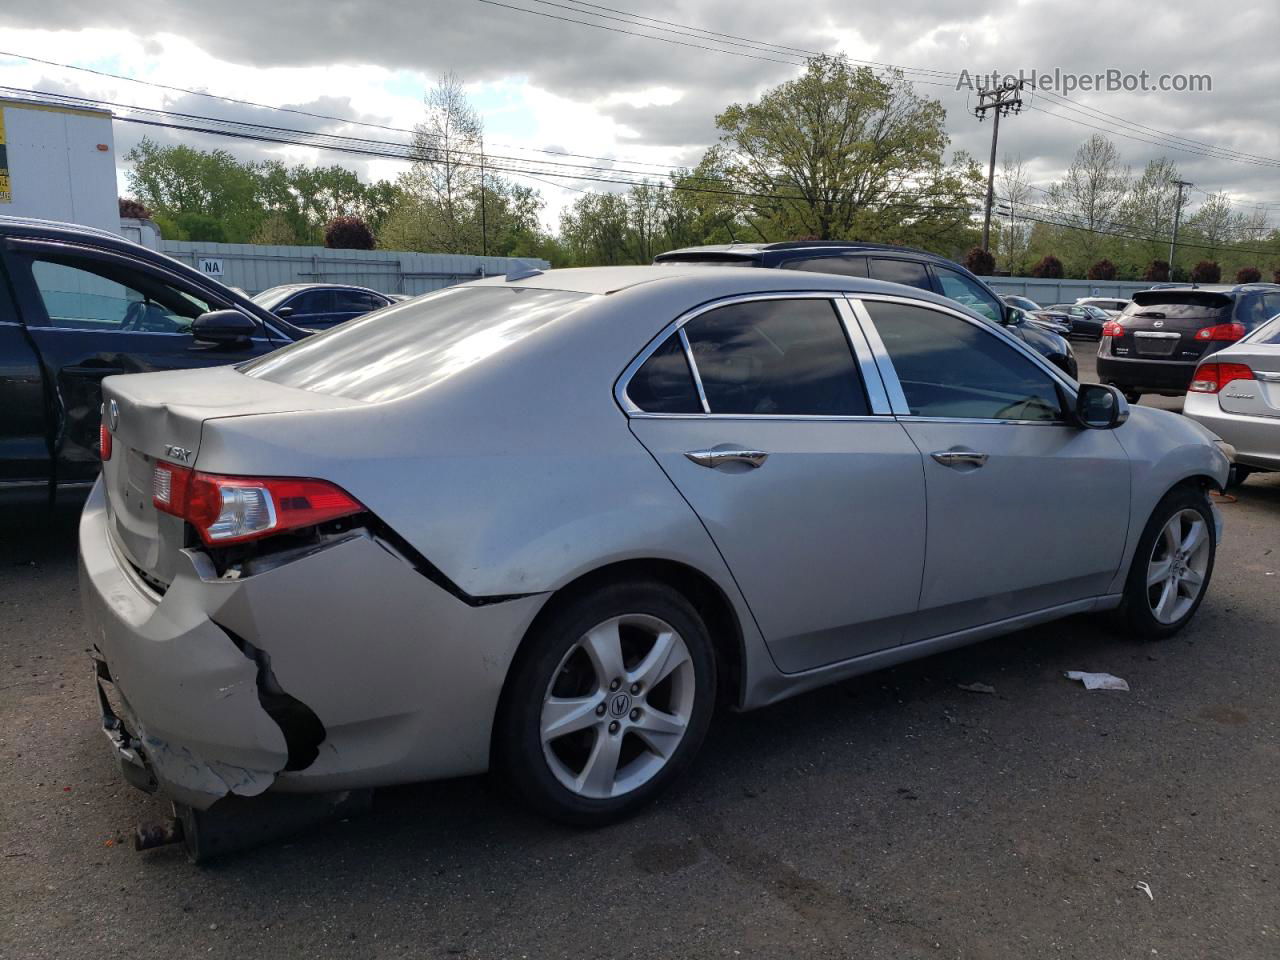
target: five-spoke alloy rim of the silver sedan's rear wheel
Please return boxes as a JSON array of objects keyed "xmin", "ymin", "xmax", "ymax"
[{"xmin": 539, "ymin": 613, "xmax": 695, "ymax": 800}]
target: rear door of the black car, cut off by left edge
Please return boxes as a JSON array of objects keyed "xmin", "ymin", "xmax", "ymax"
[{"xmin": 0, "ymin": 265, "xmax": 50, "ymax": 497}]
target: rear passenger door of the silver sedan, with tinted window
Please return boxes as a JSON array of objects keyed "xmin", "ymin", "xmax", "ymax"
[{"xmin": 620, "ymin": 293, "xmax": 924, "ymax": 672}]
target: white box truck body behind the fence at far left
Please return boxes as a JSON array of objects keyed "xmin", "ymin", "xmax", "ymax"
[{"xmin": 0, "ymin": 97, "xmax": 120, "ymax": 233}]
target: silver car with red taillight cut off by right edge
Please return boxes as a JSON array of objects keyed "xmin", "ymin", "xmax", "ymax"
[{"xmin": 1183, "ymin": 316, "xmax": 1280, "ymax": 484}]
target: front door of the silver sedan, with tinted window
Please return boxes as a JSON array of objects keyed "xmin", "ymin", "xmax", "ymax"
[{"xmin": 860, "ymin": 297, "xmax": 1129, "ymax": 640}]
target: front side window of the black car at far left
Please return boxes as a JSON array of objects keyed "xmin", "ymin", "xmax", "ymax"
[{"xmin": 31, "ymin": 256, "xmax": 210, "ymax": 333}]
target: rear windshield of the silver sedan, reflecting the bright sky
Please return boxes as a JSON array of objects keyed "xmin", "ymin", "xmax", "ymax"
[{"xmin": 239, "ymin": 287, "xmax": 590, "ymax": 403}]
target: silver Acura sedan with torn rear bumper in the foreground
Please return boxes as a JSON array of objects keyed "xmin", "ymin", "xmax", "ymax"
[{"xmin": 81, "ymin": 265, "xmax": 1229, "ymax": 823}]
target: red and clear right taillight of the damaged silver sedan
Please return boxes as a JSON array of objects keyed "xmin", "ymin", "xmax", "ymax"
[{"xmin": 151, "ymin": 463, "xmax": 365, "ymax": 547}]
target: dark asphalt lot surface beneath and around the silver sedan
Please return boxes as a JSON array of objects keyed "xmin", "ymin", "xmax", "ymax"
[{"xmin": 0, "ymin": 343, "xmax": 1280, "ymax": 960}]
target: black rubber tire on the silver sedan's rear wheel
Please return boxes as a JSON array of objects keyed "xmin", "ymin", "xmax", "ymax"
[{"xmin": 493, "ymin": 581, "xmax": 716, "ymax": 827}]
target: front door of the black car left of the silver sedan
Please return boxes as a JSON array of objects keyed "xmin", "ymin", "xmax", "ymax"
[{"xmin": 5, "ymin": 243, "xmax": 273, "ymax": 485}]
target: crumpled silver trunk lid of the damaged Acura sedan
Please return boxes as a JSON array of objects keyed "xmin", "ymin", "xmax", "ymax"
[{"xmin": 102, "ymin": 367, "xmax": 365, "ymax": 593}]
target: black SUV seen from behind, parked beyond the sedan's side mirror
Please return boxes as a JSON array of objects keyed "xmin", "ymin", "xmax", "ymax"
[{"xmin": 1098, "ymin": 283, "xmax": 1280, "ymax": 403}]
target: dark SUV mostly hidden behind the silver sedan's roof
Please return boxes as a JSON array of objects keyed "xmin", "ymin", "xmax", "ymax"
[{"xmin": 654, "ymin": 241, "xmax": 1076, "ymax": 379}]
